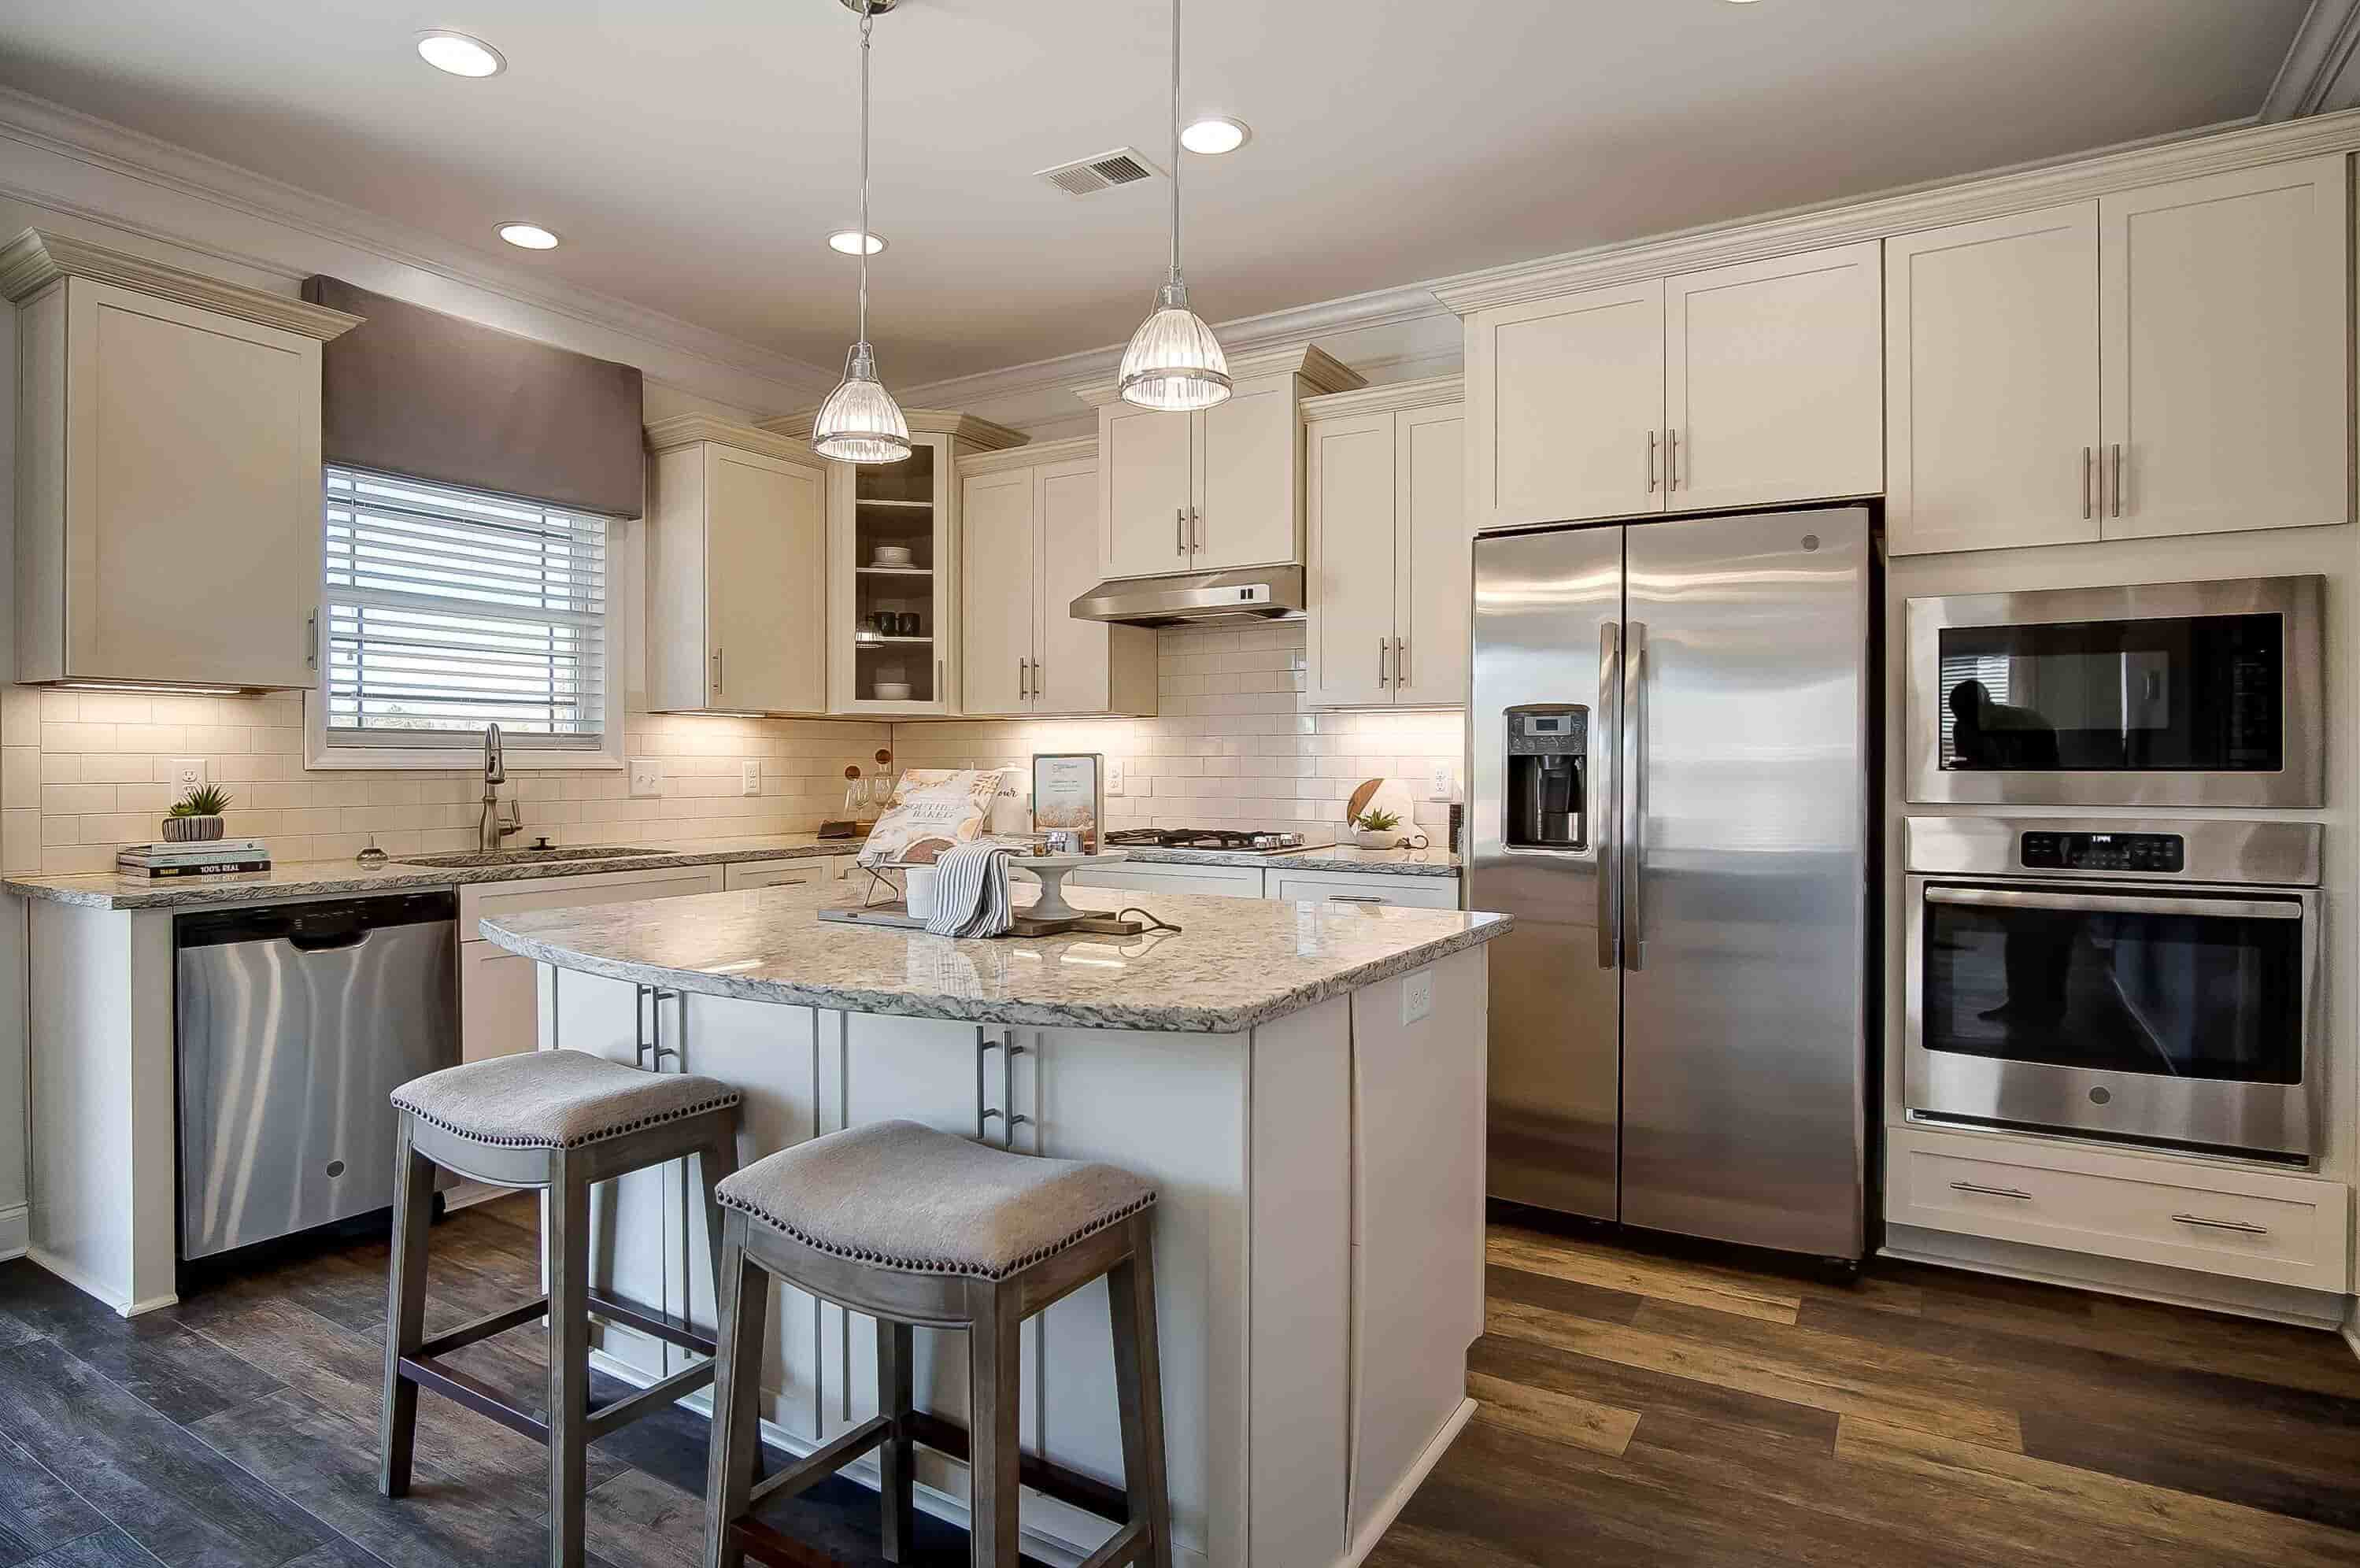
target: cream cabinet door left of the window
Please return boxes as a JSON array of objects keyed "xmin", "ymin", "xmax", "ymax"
[{"xmin": 72, "ymin": 279, "xmax": 321, "ymax": 687}]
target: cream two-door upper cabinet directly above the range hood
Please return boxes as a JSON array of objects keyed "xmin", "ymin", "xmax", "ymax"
[{"xmin": 1076, "ymin": 345, "xmax": 1359, "ymax": 576}]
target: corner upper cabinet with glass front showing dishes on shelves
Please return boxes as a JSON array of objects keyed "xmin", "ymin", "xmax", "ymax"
[{"xmin": 764, "ymin": 409, "xmax": 1024, "ymax": 718}]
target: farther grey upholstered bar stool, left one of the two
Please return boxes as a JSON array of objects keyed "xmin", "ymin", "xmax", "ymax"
[{"xmin": 378, "ymin": 1051, "xmax": 755, "ymax": 1568}]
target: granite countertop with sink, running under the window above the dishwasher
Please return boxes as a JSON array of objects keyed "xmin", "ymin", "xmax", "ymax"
[{"xmin": 0, "ymin": 834, "xmax": 859, "ymax": 909}]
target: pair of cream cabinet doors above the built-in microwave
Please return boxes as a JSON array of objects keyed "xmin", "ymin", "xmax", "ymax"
[{"xmin": 1885, "ymin": 156, "xmax": 2353, "ymax": 555}]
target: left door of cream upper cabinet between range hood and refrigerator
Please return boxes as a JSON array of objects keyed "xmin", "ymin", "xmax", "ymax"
[{"xmin": 1303, "ymin": 413, "xmax": 1387, "ymax": 708}]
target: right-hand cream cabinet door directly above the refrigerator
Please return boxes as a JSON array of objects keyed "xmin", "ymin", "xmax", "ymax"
[{"xmin": 1664, "ymin": 241, "xmax": 1885, "ymax": 510}]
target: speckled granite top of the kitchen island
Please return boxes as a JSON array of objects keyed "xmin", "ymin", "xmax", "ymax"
[{"xmin": 470, "ymin": 883, "xmax": 1513, "ymax": 1034}]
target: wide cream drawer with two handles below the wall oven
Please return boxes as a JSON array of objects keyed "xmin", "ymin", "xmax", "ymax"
[{"xmin": 1888, "ymin": 1129, "xmax": 2348, "ymax": 1292}]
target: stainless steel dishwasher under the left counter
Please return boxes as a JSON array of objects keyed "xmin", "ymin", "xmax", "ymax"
[{"xmin": 172, "ymin": 893, "xmax": 458, "ymax": 1259}]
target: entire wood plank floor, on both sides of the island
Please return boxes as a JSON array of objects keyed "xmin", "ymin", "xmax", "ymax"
[{"xmin": 0, "ymin": 1200, "xmax": 2360, "ymax": 1568}]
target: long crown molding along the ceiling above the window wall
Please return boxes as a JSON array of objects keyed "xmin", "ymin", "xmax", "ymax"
[{"xmin": 0, "ymin": 87, "xmax": 835, "ymax": 404}]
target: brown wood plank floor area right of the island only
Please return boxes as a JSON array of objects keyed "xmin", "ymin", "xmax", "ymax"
[{"xmin": 1369, "ymin": 1223, "xmax": 2360, "ymax": 1568}]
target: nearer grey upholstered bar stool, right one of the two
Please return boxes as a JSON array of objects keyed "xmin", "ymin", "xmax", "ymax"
[{"xmin": 705, "ymin": 1122, "xmax": 1173, "ymax": 1568}]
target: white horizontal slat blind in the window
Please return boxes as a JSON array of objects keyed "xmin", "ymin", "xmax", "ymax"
[{"xmin": 321, "ymin": 468, "xmax": 606, "ymax": 749}]
